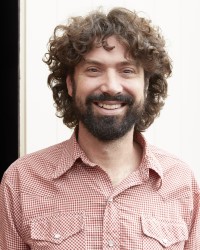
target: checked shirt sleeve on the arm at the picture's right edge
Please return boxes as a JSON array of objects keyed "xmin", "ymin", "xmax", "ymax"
[{"xmin": 184, "ymin": 176, "xmax": 200, "ymax": 250}]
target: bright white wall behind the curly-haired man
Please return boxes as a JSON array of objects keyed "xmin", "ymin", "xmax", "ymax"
[{"xmin": 20, "ymin": 0, "xmax": 200, "ymax": 184}]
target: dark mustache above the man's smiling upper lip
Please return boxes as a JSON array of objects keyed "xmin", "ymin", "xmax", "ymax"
[{"xmin": 86, "ymin": 93, "xmax": 134, "ymax": 106}]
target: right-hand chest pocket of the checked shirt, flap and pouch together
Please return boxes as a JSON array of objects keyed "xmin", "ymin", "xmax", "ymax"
[{"xmin": 141, "ymin": 216, "xmax": 188, "ymax": 250}]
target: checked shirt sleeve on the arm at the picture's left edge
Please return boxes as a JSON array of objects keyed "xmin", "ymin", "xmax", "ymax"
[{"xmin": 0, "ymin": 174, "xmax": 30, "ymax": 250}]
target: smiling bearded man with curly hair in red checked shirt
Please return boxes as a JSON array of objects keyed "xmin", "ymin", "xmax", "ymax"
[{"xmin": 0, "ymin": 8, "xmax": 200, "ymax": 250}]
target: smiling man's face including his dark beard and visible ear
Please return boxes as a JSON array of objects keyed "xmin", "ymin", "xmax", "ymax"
[{"xmin": 67, "ymin": 37, "xmax": 145, "ymax": 141}]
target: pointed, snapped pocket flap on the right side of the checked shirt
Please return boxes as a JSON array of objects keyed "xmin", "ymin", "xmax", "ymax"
[{"xmin": 141, "ymin": 216, "xmax": 188, "ymax": 247}]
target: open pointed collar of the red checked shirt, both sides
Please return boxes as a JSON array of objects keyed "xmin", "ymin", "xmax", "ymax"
[{"xmin": 52, "ymin": 129, "xmax": 163, "ymax": 188}]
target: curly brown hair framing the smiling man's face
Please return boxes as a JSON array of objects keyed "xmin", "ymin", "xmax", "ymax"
[{"xmin": 43, "ymin": 8, "xmax": 172, "ymax": 131}]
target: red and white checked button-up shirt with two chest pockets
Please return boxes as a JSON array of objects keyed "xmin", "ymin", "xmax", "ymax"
[{"xmin": 0, "ymin": 134, "xmax": 200, "ymax": 250}]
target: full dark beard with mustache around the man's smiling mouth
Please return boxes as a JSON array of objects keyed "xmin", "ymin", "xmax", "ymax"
[{"xmin": 73, "ymin": 88, "xmax": 144, "ymax": 142}]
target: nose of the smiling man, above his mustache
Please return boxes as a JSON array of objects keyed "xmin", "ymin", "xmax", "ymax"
[{"xmin": 100, "ymin": 71, "xmax": 123, "ymax": 95}]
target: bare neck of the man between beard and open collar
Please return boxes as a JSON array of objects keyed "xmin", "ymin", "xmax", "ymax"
[{"xmin": 78, "ymin": 125, "xmax": 142, "ymax": 185}]
